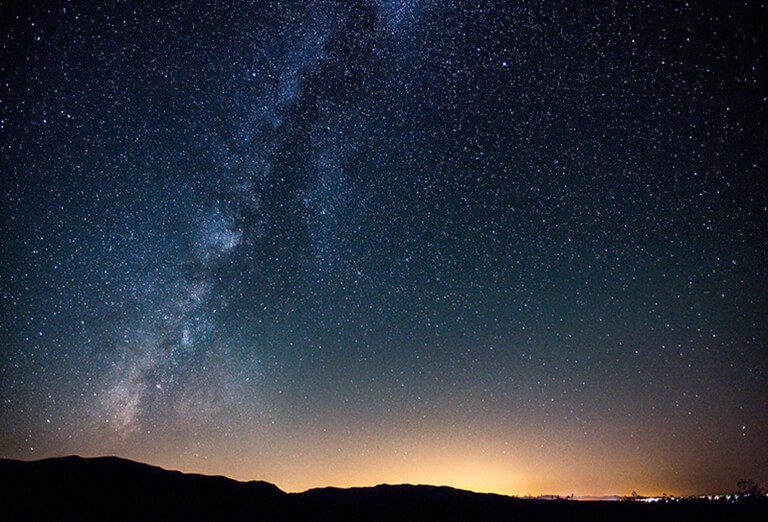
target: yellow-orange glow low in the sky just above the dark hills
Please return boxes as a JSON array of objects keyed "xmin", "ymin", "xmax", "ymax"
[{"xmin": 60, "ymin": 416, "xmax": 756, "ymax": 496}]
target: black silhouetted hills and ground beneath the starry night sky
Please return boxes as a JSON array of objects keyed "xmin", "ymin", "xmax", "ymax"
[{"xmin": 0, "ymin": 457, "xmax": 768, "ymax": 521}]
